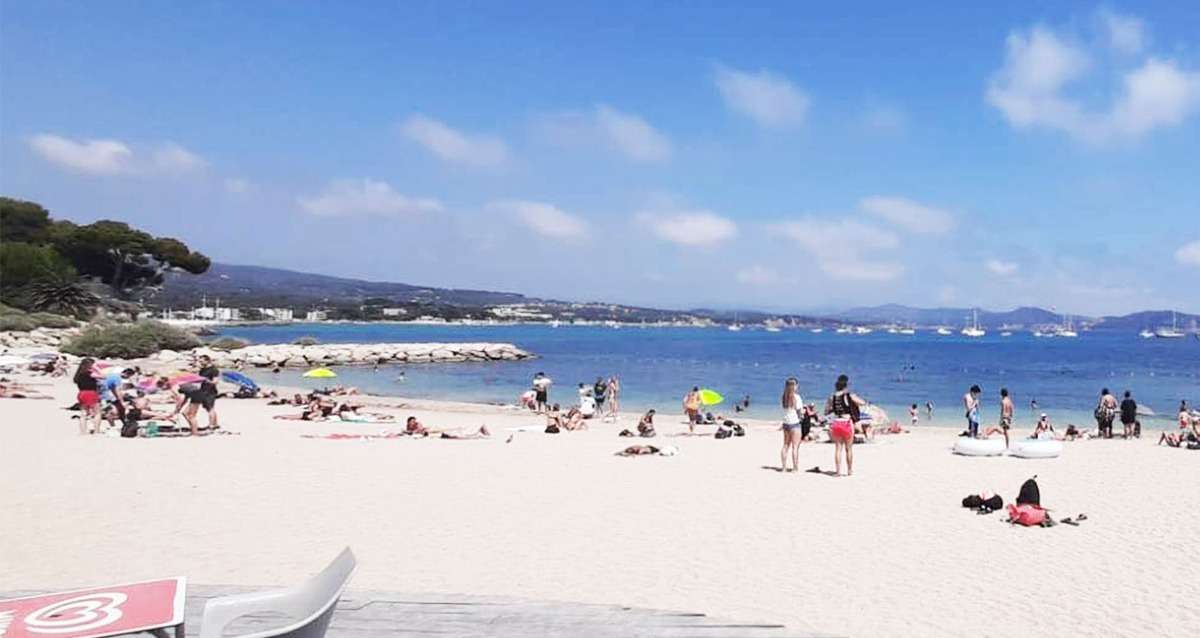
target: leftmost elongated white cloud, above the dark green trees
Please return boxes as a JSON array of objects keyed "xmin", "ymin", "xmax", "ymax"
[{"xmin": 29, "ymin": 133, "xmax": 205, "ymax": 175}]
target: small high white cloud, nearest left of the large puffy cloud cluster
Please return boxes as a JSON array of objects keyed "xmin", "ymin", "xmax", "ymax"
[{"xmin": 716, "ymin": 66, "xmax": 809, "ymax": 127}]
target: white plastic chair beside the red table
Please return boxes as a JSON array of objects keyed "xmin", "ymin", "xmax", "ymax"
[{"xmin": 200, "ymin": 547, "xmax": 358, "ymax": 638}]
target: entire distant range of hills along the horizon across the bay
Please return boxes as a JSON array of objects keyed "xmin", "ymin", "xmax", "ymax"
[{"xmin": 154, "ymin": 263, "xmax": 1200, "ymax": 331}]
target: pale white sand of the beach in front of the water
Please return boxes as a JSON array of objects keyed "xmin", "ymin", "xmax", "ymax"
[{"xmin": 0, "ymin": 374, "xmax": 1200, "ymax": 636}]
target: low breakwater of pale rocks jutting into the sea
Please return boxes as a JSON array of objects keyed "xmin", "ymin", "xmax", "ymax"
[{"xmin": 155, "ymin": 343, "xmax": 534, "ymax": 368}]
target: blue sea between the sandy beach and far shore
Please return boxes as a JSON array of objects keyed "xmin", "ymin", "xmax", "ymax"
[{"xmin": 220, "ymin": 323, "xmax": 1200, "ymax": 429}]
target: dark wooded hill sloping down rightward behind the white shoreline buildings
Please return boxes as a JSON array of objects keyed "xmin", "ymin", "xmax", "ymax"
[{"xmin": 146, "ymin": 264, "xmax": 533, "ymax": 307}]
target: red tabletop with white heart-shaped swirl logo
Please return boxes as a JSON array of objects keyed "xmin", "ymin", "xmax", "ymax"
[{"xmin": 0, "ymin": 578, "xmax": 187, "ymax": 638}]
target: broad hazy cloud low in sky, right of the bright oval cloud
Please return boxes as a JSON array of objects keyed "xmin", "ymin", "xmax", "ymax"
[{"xmin": 778, "ymin": 217, "xmax": 905, "ymax": 282}]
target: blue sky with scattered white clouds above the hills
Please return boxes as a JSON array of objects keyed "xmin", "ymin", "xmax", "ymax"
[{"xmin": 0, "ymin": 0, "xmax": 1200, "ymax": 313}]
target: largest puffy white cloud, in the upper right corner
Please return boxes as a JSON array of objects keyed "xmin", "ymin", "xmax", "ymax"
[{"xmin": 985, "ymin": 25, "xmax": 1200, "ymax": 144}]
